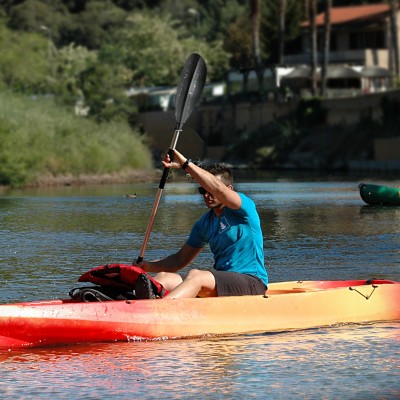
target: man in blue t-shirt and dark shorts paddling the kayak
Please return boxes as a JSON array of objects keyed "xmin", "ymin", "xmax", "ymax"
[{"xmin": 136, "ymin": 150, "xmax": 268, "ymax": 299}]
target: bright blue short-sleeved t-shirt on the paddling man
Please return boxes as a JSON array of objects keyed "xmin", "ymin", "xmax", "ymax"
[{"xmin": 187, "ymin": 193, "xmax": 268, "ymax": 285}]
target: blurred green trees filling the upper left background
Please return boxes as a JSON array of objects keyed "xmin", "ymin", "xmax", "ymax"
[{"xmin": 0, "ymin": 0, "xmax": 308, "ymax": 121}]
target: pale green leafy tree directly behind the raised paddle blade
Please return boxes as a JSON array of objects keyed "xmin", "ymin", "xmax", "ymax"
[{"xmin": 99, "ymin": 13, "xmax": 228, "ymax": 86}]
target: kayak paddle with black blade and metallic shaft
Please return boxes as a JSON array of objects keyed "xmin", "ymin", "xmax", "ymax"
[{"xmin": 133, "ymin": 53, "xmax": 207, "ymax": 264}]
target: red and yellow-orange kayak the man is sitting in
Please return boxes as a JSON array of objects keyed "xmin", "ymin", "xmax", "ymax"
[{"xmin": 0, "ymin": 280, "xmax": 400, "ymax": 349}]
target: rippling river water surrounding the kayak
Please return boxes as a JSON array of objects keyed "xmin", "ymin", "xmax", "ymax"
[{"xmin": 0, "ymin": 174, "xmax": 400, "ymax": 399}]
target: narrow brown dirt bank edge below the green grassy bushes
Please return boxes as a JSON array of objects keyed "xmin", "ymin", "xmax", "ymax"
[{"xmin": 0, "ymin": 169, "xmax": 161, "ymax": 193}]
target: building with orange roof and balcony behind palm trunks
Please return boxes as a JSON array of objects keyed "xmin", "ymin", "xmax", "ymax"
[{"xmin": 284, "ymin": 4, "xmax": 400, "ymax": 95}]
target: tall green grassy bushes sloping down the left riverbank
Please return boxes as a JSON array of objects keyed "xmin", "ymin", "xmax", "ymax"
[{"xmin": 0, "ymin": 92, "xmax": 152, "ymax": 186}]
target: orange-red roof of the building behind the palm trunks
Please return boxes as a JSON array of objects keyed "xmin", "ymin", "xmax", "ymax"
[{"xmin": 302, "ymin": 4, "xmax": 389, "ymax": 27}]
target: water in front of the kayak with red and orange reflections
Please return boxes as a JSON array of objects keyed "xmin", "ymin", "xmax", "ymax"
[{"xmin": 0, "ymin": 323, "xmax": 400, "ymax": 399}]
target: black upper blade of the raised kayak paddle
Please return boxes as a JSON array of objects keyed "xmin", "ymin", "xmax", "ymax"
[{"xmin": 175, "ymin": 53, "xmax": 207, "ymax": 130}]
